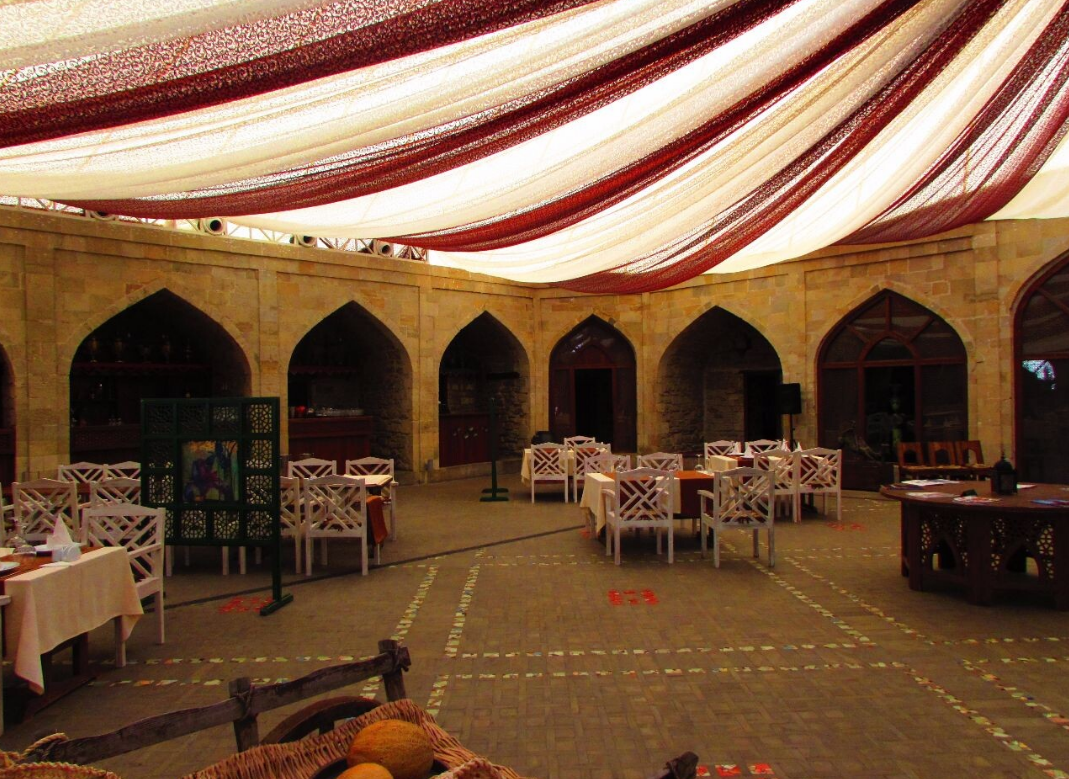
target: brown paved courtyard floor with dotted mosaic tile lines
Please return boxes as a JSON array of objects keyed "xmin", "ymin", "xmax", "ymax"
[{"xmin": 0, "ymin": 477, "xmax": 1069, "ymax": 779}]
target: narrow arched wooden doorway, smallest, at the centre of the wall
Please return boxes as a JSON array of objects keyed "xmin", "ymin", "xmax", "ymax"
[{"xmin": 549, "ymin": 316, "xmax": 637, "ymax": 452}]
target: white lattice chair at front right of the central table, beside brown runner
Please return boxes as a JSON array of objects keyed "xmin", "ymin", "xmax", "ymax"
[{"xmin": 698, "ymin": 468, "xmax": 776, "ymax": 568}]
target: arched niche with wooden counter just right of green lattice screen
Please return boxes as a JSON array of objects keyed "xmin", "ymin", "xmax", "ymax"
[{"xmin": 289, "ymin": 302, "xmax": 413, "ymax": 470}]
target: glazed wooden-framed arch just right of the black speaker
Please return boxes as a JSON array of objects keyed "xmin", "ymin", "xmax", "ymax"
[{"xmin": 817, "ymin": 290, "xmax": 969, "ymax": 461}]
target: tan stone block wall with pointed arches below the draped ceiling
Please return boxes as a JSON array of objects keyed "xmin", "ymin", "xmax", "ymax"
[{"xmin": 0, "ymin": 208, "xmax": 1069, "ymax": 478}]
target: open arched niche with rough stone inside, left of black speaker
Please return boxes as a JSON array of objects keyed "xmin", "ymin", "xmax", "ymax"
[{"xmin": 659, "ymin": 308, "xmax": 783, "ymax": 452}]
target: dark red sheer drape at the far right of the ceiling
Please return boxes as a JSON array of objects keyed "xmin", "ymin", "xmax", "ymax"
[{"xmin": 840, "ymin": 7, "xmax": 1069, "ymax": 244}]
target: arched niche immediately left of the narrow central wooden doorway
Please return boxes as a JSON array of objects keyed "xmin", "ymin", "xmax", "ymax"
[{"xmin": 438, "ymin": 312, "xmax": 530, "ymax": 467}]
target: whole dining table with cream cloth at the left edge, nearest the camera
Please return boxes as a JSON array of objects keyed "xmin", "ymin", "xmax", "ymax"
[{"xmin": 0, "ymin": 546, "xmax": 143, "ymax": 713}]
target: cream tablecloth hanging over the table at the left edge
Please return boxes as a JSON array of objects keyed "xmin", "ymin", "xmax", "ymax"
[{"xmin": 4, "ymin": 546, "xmax": 143, "ymax": 695}]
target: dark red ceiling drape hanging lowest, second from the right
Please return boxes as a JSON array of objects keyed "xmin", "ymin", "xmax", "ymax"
[{"xmin": 560, "ymin": 0, "xmax": 1005, "ymax": 294}]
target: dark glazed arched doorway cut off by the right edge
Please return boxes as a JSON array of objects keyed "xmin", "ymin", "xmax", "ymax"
[{"xmin": 1009, "ymin": 254, "xmax": 1069, "ymax": 484}]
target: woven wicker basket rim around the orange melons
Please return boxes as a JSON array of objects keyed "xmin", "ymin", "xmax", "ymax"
[{"xmin": 187, "ymin": 700, "xmax": 530, "ymax": 779}]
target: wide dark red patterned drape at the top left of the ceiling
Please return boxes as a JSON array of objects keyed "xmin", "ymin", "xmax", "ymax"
[{"xmin": 0, "ymin": 0, "xmax": 595, "ymax": 147}]
